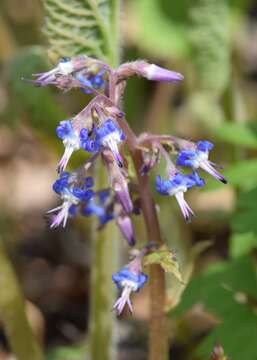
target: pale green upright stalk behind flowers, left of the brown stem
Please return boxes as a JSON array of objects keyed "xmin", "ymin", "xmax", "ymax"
[{"xmin": 89, "ymin": 0, "xmax": 120, "ymax": 360}]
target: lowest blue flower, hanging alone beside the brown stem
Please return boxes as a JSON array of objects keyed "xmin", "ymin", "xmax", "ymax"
[{"xmin": 112, "ymin": 256, "xmax": 148, "ymax": 315}]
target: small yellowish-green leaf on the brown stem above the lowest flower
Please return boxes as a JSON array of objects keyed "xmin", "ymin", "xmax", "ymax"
[{"xmin": 144, "ymin": 250, "xmax": 183, "ymax": 282}]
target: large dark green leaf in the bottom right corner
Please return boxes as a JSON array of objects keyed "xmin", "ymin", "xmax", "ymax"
[{"xmin": 172, "ymin": 257, "xmax": 257, "ymax": 360}]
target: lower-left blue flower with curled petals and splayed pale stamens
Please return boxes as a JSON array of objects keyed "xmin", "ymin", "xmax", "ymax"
[{"xmin": 47, "ymin": 172, "xmax": 94, "ymax": 228}]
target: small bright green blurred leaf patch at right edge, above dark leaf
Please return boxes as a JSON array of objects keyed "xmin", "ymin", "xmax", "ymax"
[{"xmin": 229, "ymin": 233, "xmax": 257, "ymax": 258}]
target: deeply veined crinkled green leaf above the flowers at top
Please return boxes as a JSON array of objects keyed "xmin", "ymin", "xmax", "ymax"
[{"xmin": 43, "ymin": 0, "xmax": 119, "ymax": 66}]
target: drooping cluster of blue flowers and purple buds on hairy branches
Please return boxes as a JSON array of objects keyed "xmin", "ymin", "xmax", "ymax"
[{"xmin": 26, "ymin": 56, "xmax": 226, "ymax": 314}]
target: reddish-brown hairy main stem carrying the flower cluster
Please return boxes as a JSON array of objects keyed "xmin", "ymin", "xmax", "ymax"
[{"xmin": 116, "ymin": 120, "xmax": 168, "ymax": 360}]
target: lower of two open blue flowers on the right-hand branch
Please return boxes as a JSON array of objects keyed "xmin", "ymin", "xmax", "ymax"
[{"xmin": 156, "ymin": 171, "xmax": 201, "ymax": 222}]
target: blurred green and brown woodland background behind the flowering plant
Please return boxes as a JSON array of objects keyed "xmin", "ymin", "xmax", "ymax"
[{"xmin": 0, "ymin": 0, "xmax": 257, "ymax": 360}]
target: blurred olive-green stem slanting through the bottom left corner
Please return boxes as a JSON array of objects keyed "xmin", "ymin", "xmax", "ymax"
[{"xmin": 0, "ymin": 242, "xmax": 44, "ymax": 360}]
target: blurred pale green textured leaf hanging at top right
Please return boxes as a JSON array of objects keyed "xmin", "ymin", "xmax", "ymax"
[{"xmin": 189, "ymin": 0, "xmax": 230, "ymax": 97}]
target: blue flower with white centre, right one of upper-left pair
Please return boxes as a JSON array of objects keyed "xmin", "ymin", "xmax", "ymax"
[{"xmin": 95, "ymin": 119, "xmax": 125, "ymax": 167}]
